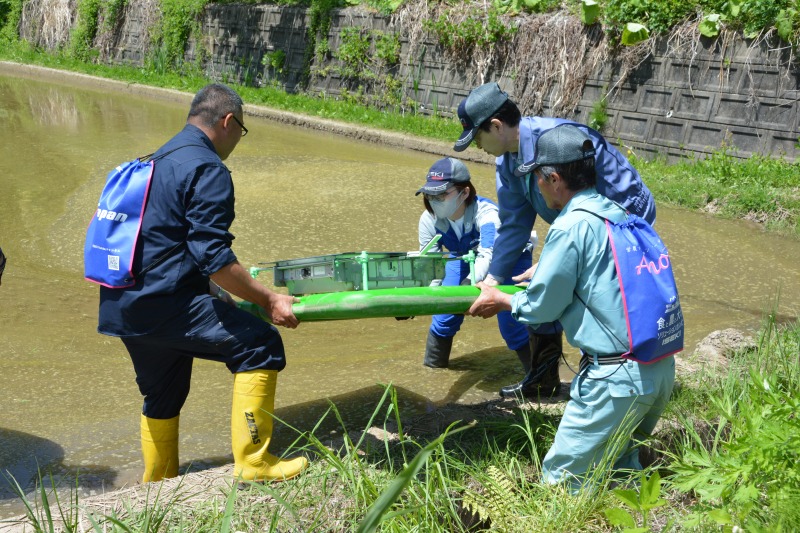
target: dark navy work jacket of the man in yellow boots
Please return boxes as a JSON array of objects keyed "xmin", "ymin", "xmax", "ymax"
[{"xmin": 97, "ymin": 124, "xmax": 236, "ymax": 337}]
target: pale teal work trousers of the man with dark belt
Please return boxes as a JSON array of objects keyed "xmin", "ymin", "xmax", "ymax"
[{"xmin": 542, "ymin": 356, "xmax": 675, "ymax": 492}]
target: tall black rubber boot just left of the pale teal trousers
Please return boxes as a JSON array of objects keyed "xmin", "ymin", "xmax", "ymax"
[{"xmin": 500, "ymin": 333, "xmax": 562, "ymax": 398}]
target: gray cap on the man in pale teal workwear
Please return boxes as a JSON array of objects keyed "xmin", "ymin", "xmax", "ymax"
[{"xmin": 514, "ymin": 124, "xmax": 595, "ymax": 176}]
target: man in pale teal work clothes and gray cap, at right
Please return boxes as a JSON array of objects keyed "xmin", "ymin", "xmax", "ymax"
[{"xmin": 468, "ymin": 124, "xmax": 675, "ymax": 488}]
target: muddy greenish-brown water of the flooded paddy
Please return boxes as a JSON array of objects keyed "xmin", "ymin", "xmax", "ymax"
[{"xmin": 0, "ymin": 68, "xmax": 800, "ymax": 516}]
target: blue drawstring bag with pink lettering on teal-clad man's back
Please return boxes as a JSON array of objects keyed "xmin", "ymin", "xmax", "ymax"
[{"xmin": 576, "ymin": 209, "xmax": 684, "ymax": 363}]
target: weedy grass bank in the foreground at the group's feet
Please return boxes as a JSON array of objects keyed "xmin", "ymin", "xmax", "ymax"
[{"xmin": 10, "ymin": 316, "xmax": 800, "ymax": 533}]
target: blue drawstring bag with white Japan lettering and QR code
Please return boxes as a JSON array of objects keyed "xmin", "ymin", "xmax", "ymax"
[{"xmin": 83, "ymin": 156, "xmax": 155, "ymax": 289}]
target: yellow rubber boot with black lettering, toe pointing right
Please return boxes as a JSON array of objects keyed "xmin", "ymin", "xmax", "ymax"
[{"xmin": 231, "ymin": 370, "xmax": 308, "ymax": 481}]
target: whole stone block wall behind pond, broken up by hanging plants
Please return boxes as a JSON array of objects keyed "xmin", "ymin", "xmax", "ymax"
[{"xmin": 109, "ymin": 4, "xmax": 800, "ymax": 160}]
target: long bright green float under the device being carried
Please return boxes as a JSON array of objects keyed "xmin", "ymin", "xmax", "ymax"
[{"xmin": 239, "ymin": 285, "xmax": 524, "ymax": 322}]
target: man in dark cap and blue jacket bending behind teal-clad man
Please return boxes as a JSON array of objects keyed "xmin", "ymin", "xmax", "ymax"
[{"xmin": 453, "ymin": 83, "xmax": 656, "ymax": 398}]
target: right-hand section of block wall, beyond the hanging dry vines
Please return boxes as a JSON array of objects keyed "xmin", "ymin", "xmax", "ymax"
[{"xmin": 576, "ymin": 39, "xmax": 800, "ymax": 160}]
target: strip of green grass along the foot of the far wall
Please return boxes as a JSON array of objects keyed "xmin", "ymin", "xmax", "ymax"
[{"xmin": 0, "ymin": 42, "xmax": 800, "ymax": 237}]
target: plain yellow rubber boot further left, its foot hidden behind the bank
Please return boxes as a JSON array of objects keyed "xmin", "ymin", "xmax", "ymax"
[{"xmin": 141, "ymin": 415, "xmax": 180, "ymax": 483}]
